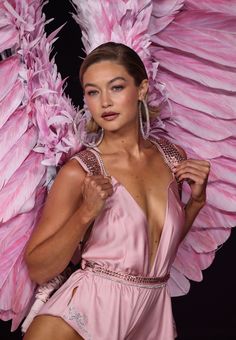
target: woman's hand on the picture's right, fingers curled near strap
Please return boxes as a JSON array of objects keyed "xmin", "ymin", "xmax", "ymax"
[{"xmin": 173, "ymin": 159, "xmax": 210, "ymax": 203}]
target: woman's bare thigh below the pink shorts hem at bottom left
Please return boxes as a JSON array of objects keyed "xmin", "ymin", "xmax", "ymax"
[{"xmin": 23, "ymin": 315, "xmax": 83, "ymax": 340}]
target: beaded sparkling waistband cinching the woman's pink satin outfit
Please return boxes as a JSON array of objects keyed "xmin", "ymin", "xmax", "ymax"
[{"xmin": 83, "ymin": 261, "xmax": 170, "ymax": 288}]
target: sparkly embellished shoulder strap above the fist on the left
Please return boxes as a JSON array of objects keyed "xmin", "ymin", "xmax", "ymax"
[{"xmin": 71, "ymin": 149, "xmax": 103, "ymax": 176}]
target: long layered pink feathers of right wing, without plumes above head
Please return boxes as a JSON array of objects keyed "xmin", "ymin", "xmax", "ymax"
[{"xmin": 152, "ymin": 1, "xmax": 236, "ymax": 295}]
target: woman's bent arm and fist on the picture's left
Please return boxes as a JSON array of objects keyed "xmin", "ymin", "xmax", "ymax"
[{"xmin": 25, "ymin": 160, "xmax": 112, "ymax": 284}]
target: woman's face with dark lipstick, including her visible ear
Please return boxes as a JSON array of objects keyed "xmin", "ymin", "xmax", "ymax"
[{"xmin": 83, "ymin": 61, "xmax": 148, "ymax": 132}]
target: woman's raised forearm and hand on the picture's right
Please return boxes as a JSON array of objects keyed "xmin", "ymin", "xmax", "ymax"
[{"xmin": 174, "ymin": 159, "xmax": 210, "ymax": 236}]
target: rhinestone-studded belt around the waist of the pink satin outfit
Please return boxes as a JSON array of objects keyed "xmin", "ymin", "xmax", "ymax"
[{"xmin": 83, "ymin": 261, "xmax": 170, "ymax": 284}]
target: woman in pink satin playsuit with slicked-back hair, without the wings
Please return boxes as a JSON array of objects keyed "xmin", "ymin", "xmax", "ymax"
[{"xmin": 24, "ymin": 43, "xmax": 209, "ymax": 340}]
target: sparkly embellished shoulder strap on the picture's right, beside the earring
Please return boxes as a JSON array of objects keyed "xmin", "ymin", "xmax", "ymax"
[{"xmin": 150, "ymin": 138, "xmax": 186, "ymax": 170}]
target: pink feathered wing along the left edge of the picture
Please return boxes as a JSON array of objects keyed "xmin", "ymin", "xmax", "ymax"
[{"xmin": 0, "ymin": 0, "xmax": 79, "ymax": 330}]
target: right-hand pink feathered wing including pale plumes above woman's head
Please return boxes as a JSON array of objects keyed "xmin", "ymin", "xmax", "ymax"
[{"xmin": 73, "ymin": 0, "xmax": 236, "ymax": 295}]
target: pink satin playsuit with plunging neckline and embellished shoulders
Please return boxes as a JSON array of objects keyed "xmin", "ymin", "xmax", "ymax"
[{"xmin": 39, "ymin": 137, "xmax": 184, "ymax": 340}]
